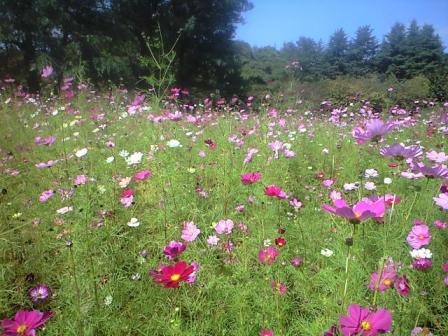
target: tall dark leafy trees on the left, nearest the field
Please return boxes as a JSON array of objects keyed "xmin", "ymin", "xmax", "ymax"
[{"xmin": 0, "ymin": 0, "xmax": 252, "ymax": 91}]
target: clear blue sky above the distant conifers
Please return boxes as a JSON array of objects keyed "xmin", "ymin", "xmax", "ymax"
[{"xmin": 235, "ymin": 0, "xmax": 448, "ymax": 50}]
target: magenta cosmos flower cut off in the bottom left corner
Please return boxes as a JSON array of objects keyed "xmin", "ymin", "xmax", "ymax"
[{"xmin": 1, "ymin": 310, "xmax": 54, "ymax": 336}]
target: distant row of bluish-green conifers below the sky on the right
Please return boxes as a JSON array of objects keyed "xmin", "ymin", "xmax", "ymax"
[{"xmin": 236, "ymin": 21, "xmax": 448, "ymax": 83}]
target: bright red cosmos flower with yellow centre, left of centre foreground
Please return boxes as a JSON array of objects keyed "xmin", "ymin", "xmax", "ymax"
[{"xmin": 150, "ymin": 261, "xmax": 194, "ymax": 288}]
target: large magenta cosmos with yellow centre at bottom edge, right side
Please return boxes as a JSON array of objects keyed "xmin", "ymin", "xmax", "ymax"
[{"xmin": 339, "ymin": 304, "xmax": 392, "ymax": 336}]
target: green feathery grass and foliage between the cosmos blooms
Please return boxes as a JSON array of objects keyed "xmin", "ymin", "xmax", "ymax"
[{"xmin": 0, "ymin": 93, "xmax": 448, "ymax": 336}]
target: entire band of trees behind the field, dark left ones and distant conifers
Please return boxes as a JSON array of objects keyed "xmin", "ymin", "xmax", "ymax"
[{"xmin": 0, "ymin": 0, "xmax": 448, "ymax": 99}]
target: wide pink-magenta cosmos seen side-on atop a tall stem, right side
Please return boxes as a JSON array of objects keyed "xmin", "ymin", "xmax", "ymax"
[{"xmin": 322, "ymin": 198, "xmax": 386, "ymax": 224}]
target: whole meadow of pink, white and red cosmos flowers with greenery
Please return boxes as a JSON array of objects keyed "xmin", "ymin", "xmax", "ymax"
[{"xmin": 0, "ymin": 85, "xmax": 448, "ymax": 336}]
